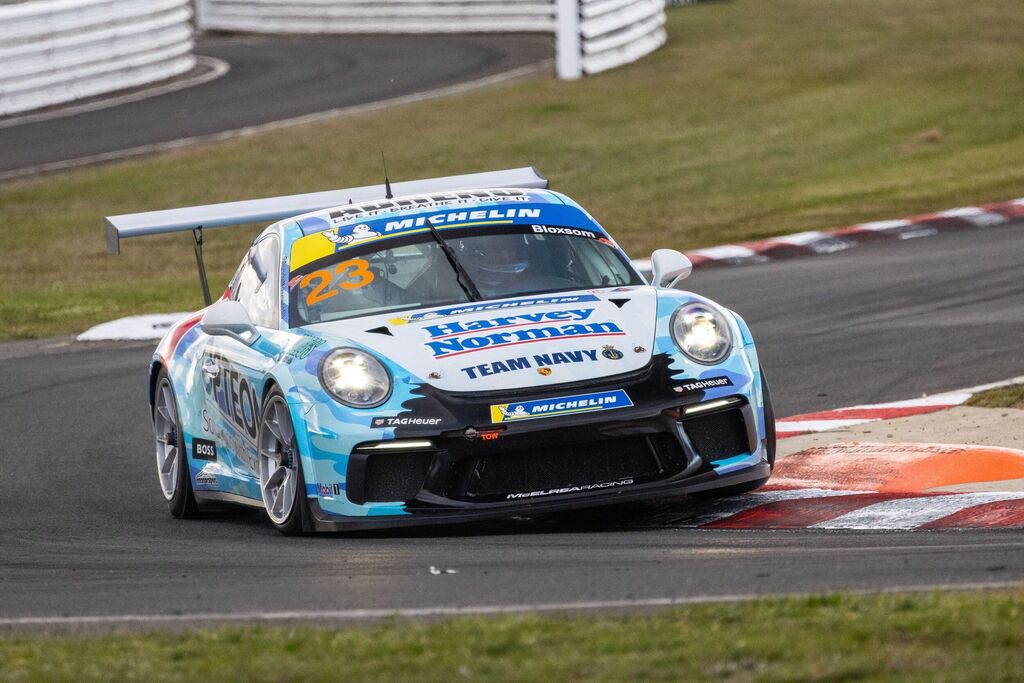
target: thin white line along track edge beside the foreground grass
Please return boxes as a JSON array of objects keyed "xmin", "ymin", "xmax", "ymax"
[{"xmin": 0, "ymin": 582, "xmax": 1024, "ymax": 628}]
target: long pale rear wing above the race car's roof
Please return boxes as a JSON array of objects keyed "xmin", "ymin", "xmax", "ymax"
[{"xmin": 106, "ymin": 166, "xmax": 548, "ymax": 254}]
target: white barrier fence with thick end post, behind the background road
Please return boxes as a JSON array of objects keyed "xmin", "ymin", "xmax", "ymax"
[{"xmin": 198, "ymin": 0, "xmax": 666, "ymax": 78}]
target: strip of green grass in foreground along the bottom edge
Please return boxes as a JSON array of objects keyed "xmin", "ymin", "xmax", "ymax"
[{"xmin": 0, "ymin": 591, "xmax": 1024, "ymax": 683}]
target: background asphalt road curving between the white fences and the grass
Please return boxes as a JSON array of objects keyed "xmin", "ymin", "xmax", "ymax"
[{"xmin": 0, "ymin": 35, "xmax": 554, "ymax": 174}]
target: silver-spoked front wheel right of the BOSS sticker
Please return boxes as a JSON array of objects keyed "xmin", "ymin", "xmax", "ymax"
[{"xmin": 257, "ymin": 387, "xmax": 308, "ymax": 536}]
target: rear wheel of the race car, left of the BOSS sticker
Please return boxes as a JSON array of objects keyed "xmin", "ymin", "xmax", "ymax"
[{"xmin": 153, "ymin": 369, "xmax": 199, "ymax": 519}]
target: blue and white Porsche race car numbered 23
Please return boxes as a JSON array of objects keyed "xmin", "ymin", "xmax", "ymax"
[{"xmin": 106, "ymin": 168, "xmax": 775, "ymax": 535}]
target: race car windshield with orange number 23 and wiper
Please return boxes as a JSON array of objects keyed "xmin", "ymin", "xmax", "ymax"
[{"xmin": 289, "ymin": 225, "xmax": 643, "ymax": 327}]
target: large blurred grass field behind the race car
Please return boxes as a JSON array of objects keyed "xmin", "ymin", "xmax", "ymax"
[{"xmin": 0, "ymin": 0, "xmax": 1024, "ymax": 339}]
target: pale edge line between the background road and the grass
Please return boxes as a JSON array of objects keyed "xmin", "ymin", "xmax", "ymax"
[{"xmin": 0, "ymin": 59, "xmax": 554, "ymax": 181}]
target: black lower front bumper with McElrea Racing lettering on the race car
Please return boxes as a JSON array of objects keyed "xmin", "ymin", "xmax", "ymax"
[{"xmin": 299, "ymin": 358, "xmax": 770, "ymax": 530}]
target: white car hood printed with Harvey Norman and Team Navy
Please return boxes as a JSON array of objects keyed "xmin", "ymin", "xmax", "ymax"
[{"xmin": 307, "ymin": 286, "xmax": 657, "ymax": 391}]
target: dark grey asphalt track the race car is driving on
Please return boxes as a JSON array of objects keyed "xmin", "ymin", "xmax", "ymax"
[{"xmin": 0, "ymin": 223, "xmax": 1024, "ymax": 630}]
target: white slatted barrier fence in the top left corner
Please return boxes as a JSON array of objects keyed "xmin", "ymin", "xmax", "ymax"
[{"xmin": 0, "ymin": 0, "xmax": 196, "ymax": 116}]
